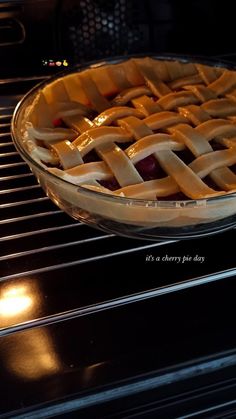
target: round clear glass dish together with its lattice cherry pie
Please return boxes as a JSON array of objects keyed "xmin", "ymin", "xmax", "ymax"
[{"xmin": 12, "ymin": 56, "xmax": 236, "ymax": 240}]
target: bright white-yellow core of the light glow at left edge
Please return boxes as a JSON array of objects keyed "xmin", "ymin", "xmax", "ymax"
[{"xmin": 0, "ymin": 286, "xmax": 33, "ymax": 317}]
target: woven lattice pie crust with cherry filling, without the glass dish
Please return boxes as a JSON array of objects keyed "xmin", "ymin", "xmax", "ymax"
[{"xmin": 25, "ymin": 57, "xmax": 236, "ymax": 200}]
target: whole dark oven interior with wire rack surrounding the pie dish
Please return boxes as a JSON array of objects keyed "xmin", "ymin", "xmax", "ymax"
[{"xmin": 0, "ymin": 0, "xmax": 236, "ymax": 419}]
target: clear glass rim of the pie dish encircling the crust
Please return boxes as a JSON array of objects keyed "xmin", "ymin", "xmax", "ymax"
[{"xmin": 11, "ymin": 52, "xmax": 236, "ymax": 209}]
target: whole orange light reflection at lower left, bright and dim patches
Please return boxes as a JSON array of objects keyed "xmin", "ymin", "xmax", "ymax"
[{"xmin": 0, "ymin": 278, "xmax": 61, "ymax": 380}]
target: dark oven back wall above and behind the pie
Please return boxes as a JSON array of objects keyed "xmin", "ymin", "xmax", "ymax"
[{"xmin": 0, "ymin": 0, "xmax": 234, "ymax": 77}]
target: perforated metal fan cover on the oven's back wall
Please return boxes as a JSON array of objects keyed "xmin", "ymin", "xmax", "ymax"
[{"xmin": 59, "ymin": 0, "xmax": 150, "ymax": 62}]
